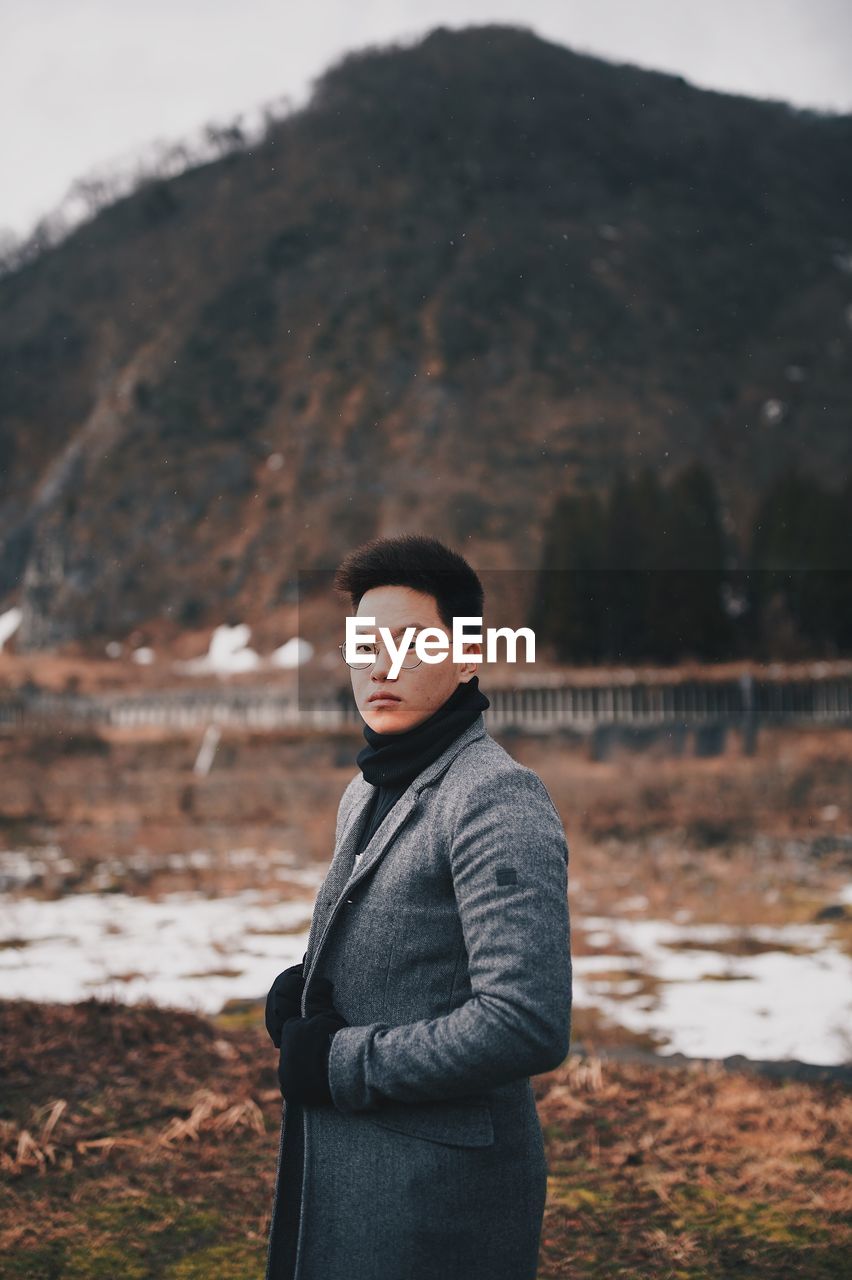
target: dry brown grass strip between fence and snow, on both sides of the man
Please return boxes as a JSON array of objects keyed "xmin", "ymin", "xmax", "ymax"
[{"xmin": 0, "ymin": 730, "xmax": 852, "ymax": 924}]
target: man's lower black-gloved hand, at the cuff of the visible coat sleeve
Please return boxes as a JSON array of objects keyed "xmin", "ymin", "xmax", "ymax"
[{"xmin": 278, "ymin": 978, "xmax": 349, "ymax": 1106}]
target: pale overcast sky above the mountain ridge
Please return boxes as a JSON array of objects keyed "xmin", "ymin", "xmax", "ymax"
[{"xmin": 0, "ymin": 0, "xmax": 852, "ymax": 233}]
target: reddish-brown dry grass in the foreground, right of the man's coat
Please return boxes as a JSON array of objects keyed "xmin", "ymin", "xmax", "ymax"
[{"xmin": 536, "ymin": 1059, "xmax": 852, "ymax": 1277}]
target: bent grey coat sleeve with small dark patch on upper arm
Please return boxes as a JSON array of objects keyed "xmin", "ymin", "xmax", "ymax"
[{"xmin": 329, "ymin": 768, "xmax": 572, "ymax": 1112}]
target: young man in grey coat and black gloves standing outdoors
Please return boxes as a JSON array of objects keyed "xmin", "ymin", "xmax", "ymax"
[{"xmin": 267, "ymin": 535, "xmax": 572, "ymax": 1280}]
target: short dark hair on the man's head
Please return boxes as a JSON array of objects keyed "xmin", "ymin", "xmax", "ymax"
[{"xmin": 334, "ymin": 534, "xmax": 485, "ymax": 627}]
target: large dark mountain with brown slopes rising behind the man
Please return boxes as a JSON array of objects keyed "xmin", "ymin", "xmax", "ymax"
[{"xmin": 0, "ymin": 27, "xmax": 852, "ymax": 650}]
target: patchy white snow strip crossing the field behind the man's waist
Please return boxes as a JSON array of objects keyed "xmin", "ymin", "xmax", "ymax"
[{"xmin": 0, "ymin": 875, "xmax": 852, "ymax": 1065}]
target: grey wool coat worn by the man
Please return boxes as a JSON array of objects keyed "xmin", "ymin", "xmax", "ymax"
[{"xmin": 266, "ymin": 714, "xmax": 572, "ymax": 1280}]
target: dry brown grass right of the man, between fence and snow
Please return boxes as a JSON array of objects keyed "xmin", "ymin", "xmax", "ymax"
[{"xmin": 512, "ymin": 730, "xmax": 852, "ymax": 928}]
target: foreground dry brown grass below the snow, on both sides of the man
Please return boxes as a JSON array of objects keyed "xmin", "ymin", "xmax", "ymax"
[{"xmin": 0, "ymin": 1001, "xmax": 852, "ymax": 1280}]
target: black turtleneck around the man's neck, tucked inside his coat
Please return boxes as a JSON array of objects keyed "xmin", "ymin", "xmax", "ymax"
[{"xmin": 357, "ymin": 676, "xmax": 491, "ymax": 854}]
